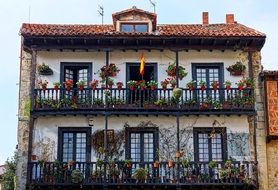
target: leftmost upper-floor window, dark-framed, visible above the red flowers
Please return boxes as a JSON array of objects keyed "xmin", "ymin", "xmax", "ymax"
[{"xmin": 61, "ymin": 63, "xmax": 92, "ymax": 87}]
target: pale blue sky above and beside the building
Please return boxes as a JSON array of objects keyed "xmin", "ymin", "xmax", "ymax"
[{"xmin": 0, "ymin": 0, "xmax": 278, "ymax": 164}]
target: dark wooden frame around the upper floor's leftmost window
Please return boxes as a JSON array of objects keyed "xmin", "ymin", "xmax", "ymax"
[{"xmin": 60, "ymin": 62, "xmax": 93, "ymax": 86}]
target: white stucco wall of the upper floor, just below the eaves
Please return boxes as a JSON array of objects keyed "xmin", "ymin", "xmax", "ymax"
[{"xmin": 37, "ymin": 50, "xmax": 248, "ymax": 87}]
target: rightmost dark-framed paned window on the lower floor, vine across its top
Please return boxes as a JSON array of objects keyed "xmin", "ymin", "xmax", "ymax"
[{"xmin": 193, "ymin": 128, "xmax": 227, "ymax": 162}]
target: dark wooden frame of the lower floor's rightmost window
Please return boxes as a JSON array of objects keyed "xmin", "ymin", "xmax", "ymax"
[{"xmin": 193, "ymin": 127, "xmax": 228, "ymax": 162}]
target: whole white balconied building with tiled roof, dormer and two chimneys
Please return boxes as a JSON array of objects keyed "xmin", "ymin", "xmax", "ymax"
[{"xmin": 17, "ymin": 7, "xmax": 268, "ymax": 189}]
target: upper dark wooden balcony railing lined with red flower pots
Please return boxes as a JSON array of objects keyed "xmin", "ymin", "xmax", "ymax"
[{"xmin": 34, "ymin": 88, "xmax": 254, "ymax": 114}]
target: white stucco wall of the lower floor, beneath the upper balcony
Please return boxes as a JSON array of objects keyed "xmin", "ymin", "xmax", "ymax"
[{"xmin": 33, "ymin": 116, "xmax": 249, "ymax": 161}]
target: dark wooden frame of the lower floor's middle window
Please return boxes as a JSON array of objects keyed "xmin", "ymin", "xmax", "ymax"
[{"xmin": 125, "ymin": 127, "xmax": 159, "ymax": 161}]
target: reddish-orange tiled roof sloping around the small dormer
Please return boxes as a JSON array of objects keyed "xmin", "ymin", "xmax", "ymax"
[{"xmin": 20, "ymin": 23, "xmax": 265, "ymax": 38}]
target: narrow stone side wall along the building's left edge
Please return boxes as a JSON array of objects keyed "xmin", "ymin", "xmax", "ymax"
[{"xmin": 16, "ymin": 49, "xmax": 32, "ymax": 190}]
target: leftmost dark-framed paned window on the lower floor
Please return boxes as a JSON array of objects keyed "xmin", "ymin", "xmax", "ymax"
[{"xmin": 58, "ymin": 128, "xmax": 91, "ymax": 162}]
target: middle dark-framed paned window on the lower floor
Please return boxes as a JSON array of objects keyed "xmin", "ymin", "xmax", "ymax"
[{"xmin": 126, "ymin": 127, "xmax": 158, "ymax": 162}]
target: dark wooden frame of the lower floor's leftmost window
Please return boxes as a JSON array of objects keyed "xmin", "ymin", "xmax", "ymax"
[{"xmin": 57, "ymin": 127, "xmax": 92, "ymax": 162}]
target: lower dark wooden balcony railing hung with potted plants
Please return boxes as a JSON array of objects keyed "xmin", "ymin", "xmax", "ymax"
[{"xmin": 28, "ymin": 162, "xmax": 256, "ymax": 186}]
